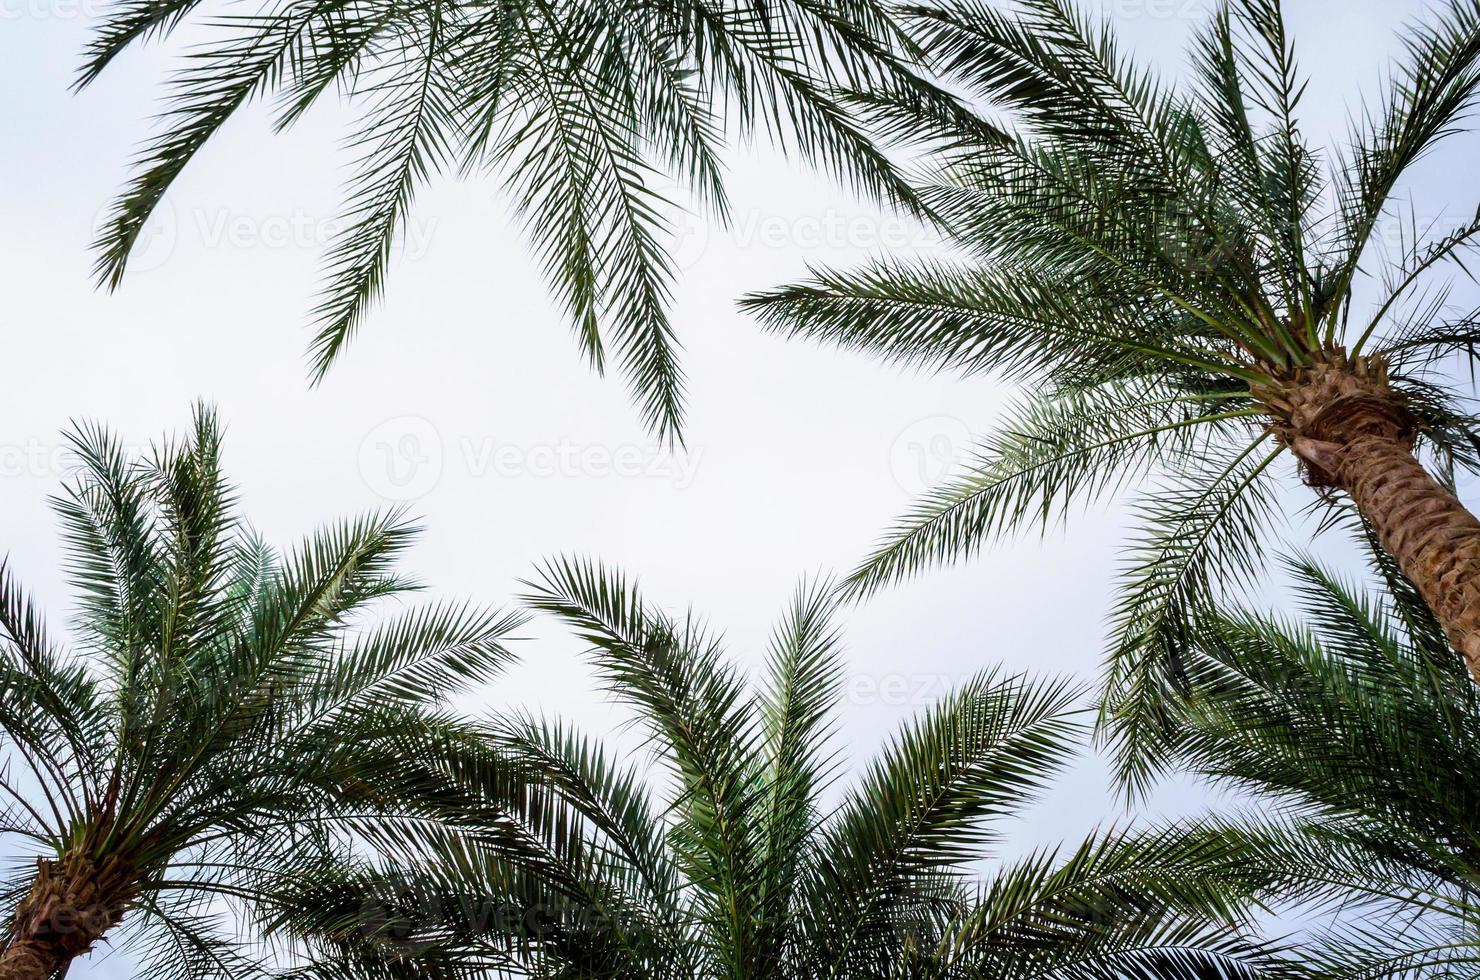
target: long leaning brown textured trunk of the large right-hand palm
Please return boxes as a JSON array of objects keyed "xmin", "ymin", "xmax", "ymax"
[{"xmin": 1255, "ymin": 351, "xmax": 1480, "ymax": 681}]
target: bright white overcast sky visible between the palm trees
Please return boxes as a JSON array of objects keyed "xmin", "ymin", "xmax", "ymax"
[{"xmin": 0, "ymin": 0, "xmax": 1476, "ymax": 979}]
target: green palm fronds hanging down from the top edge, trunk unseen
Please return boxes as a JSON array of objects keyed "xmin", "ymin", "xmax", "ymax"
[{"xmin": 78, "ymin": 0, "xmax": 955, "ymax": 437}]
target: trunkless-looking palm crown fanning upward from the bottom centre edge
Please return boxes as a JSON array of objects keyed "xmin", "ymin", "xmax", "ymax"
[{"xmin": 279, "ymin": 561, "xmax": 1296, "ymax": 980}]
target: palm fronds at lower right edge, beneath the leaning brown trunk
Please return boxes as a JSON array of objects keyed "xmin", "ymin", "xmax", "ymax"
[{"xmin": 1175, "ymin": 558, "xmax": 1480, "ymax": 977}]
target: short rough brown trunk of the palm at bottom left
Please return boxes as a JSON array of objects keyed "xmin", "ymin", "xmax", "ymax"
[{"xmin": 0, "ymin": 854, "xmax": 135, "ymax": 980}]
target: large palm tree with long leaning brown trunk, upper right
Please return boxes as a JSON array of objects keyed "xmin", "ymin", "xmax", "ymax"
[{"xmin": 746, "ymin": 0, "xmax": 1480, "ymax": 776}]
